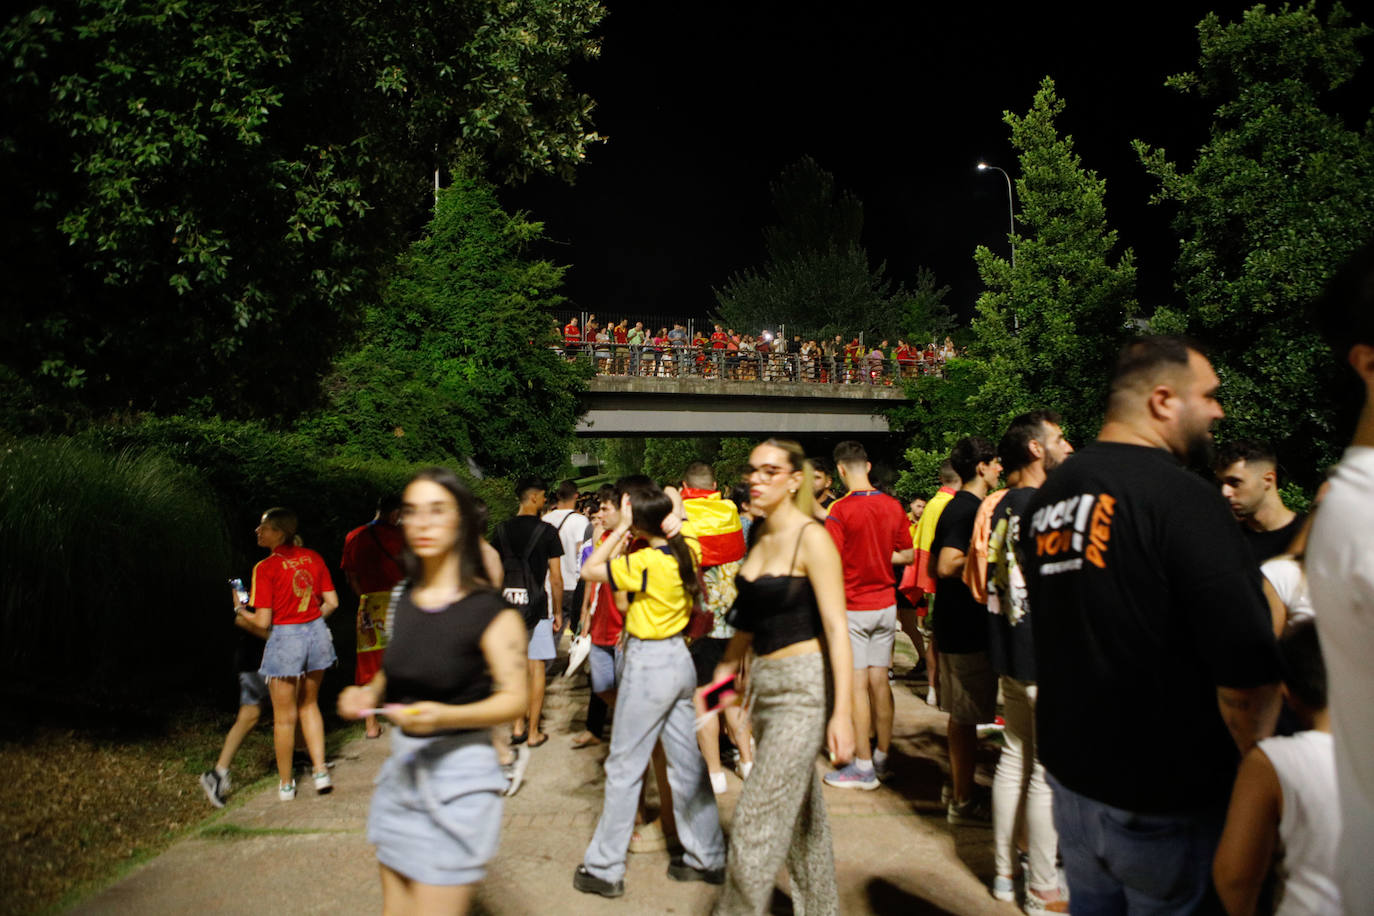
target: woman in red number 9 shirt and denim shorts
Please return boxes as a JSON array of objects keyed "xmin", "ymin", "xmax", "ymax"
[{"xmin": 245, "ymin": 507, "xmax": 339, "ymax": 802}]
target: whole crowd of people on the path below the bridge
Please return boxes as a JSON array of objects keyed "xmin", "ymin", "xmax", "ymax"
[{"xmin": 193, "ymin": 249, "xmax": 1374, "ymax": 913}]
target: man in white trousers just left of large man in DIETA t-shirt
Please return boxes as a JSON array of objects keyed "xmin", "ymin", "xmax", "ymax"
[{"xmin": 987, "ymin": 411, "xmax": 1073, "ymax": 912}]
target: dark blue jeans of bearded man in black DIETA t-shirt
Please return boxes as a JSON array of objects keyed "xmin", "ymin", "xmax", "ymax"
[{"xmin": 1048, "ymin": 775, "xmax": 1226, "ymax": 916}]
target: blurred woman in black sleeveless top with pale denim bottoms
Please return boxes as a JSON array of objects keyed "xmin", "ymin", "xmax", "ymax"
[{"xmin": 338, "ymin": 468, "xmax": 525, "ymax": 913}]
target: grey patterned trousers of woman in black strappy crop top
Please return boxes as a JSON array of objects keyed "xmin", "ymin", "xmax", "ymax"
[{"xmin": 714, "ymin": 652, "xmax": 838, "ymax": 916}]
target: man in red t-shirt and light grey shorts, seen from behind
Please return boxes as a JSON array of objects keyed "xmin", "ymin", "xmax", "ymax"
[{"xmin": 824, "ymin": 441, "xmax": 914, "ymax": 790}]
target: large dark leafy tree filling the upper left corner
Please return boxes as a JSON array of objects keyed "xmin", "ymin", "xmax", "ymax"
[{"xmin": 0, "ymin": 0, "xmax": 603, "ymax": 416}]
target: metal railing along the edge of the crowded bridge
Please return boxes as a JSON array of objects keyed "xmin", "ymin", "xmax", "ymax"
[{"xmin": 554, "ymin": 343, "xmax": 944, "ymax": 385}]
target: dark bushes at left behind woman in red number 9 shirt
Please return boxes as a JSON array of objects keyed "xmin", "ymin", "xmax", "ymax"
[{"xmin": 0, "ymin": 417, "xmax": 515, "ymax": 703}]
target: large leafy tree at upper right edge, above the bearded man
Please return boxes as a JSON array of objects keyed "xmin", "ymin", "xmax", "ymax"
[{"xmin": 1135, "ymin": 3, "xmax": 1374, "ymax": 483}]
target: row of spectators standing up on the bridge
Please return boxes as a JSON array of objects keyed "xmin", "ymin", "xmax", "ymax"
[{"xmin": 562, "ymin": 314, "xmax": 959, "ymax": 385}]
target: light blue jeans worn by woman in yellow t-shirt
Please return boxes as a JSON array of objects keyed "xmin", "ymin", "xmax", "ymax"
[{"xmin": 583, "ymin": 636, "xmax": 725, "ymax": 882}]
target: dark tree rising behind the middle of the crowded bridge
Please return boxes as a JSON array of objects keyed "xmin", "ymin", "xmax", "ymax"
[{"xmin": 716, "ymin": 157, "xmax": 901, "ymax": 336}]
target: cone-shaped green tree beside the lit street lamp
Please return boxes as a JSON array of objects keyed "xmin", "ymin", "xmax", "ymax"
[{"xmin": 970, "ymin": 77, "xmax": 1135, "ymax": 437}]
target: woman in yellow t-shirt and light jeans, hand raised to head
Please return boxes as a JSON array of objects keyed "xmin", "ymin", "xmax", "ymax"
[{"xmin": 573, "ymin": 483, "xmax": 725, "ymax": 897}]
